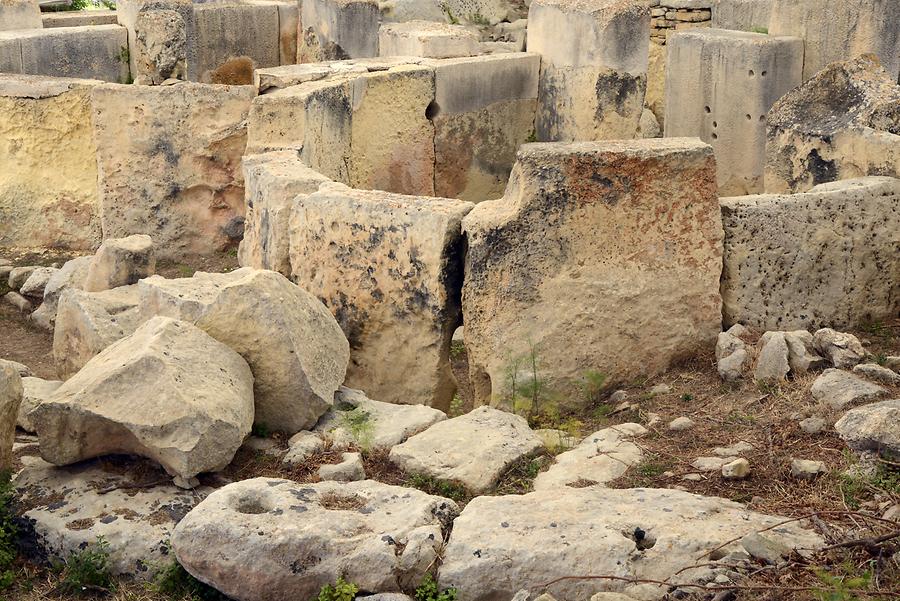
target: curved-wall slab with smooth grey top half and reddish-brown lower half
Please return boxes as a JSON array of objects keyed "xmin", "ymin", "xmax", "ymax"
[{"xmin": 431, "ymin": 53, "xmax": 541, "ymax": 202}]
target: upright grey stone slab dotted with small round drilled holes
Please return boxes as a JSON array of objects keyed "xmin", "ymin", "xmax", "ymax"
[{"xmin": 665, "ymin": 29, "xmax": 803, "ymax": 196}]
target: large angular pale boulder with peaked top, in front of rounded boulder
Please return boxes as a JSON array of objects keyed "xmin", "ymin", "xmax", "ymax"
[{"xmin": 30, "ymin": 317, "xmax": 253, "ymax": 482}]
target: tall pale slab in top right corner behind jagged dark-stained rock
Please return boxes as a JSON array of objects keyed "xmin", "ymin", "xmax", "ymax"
[{"xmin": 769, "ymin": 0, "xmax": 900, "ymax": 81}]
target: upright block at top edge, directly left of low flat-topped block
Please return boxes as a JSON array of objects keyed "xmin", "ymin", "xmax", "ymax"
[{"xmin": 297, "ymin": 0, "xmax": 380, "ymax": 63}]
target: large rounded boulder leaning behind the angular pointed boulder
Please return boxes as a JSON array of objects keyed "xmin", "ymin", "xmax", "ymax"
[{"xmin": 138, "ymin": 268, "xmax": 350, "ymax": 434}]
